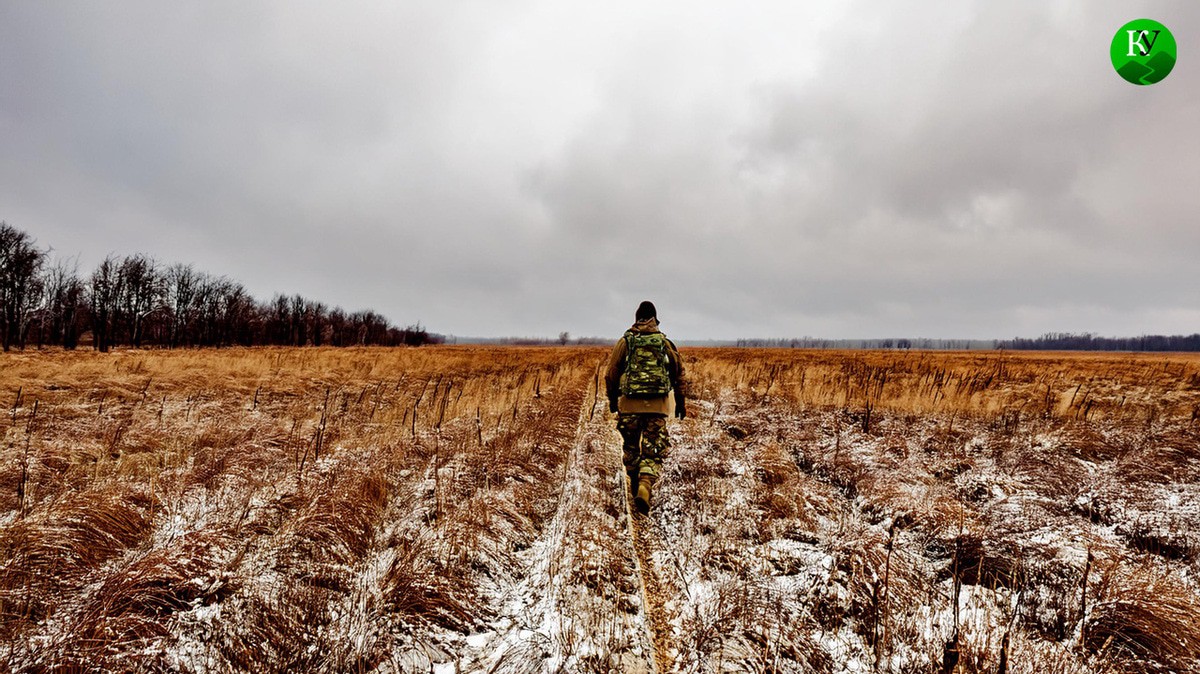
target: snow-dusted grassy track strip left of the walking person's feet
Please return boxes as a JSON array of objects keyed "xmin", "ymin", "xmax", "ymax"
[{"xmin": 473, "ymin": 381, "xmax": 664, "ymax": 674}]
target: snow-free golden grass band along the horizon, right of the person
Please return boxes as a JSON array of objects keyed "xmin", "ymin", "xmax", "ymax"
[{"xmin": 691, "ymin": 349, "xmax": 1200, "ymax": 426}]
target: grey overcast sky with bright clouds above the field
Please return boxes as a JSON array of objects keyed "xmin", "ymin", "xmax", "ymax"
[{"xmin": 0, "ymin": 0, "xmax": 1200, "ymax": 339}]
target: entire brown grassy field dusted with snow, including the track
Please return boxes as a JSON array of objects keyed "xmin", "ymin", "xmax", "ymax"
[{"xmin": 0, "ymin": 347, "xmax": 1200, "ymax": 674}]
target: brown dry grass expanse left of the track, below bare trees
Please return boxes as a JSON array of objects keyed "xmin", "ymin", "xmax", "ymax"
[{"xmin": 0, "ymin": 348, "xmax": 599, "ymax": 672}]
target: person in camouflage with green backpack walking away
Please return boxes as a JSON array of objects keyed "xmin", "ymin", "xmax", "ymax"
[{"xmin": 605, "ymin": 301, "xmax": 688, "ymax": 514}]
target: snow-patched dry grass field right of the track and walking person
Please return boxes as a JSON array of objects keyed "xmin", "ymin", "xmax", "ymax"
[{"xmin": 658, "ymin": 350, "xmax": 1200, "ymax": 673}]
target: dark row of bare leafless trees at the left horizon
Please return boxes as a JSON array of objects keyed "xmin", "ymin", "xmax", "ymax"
[{"xmin": 0, "ymin": 222, "xmax": 439, "ymax": 351}]
